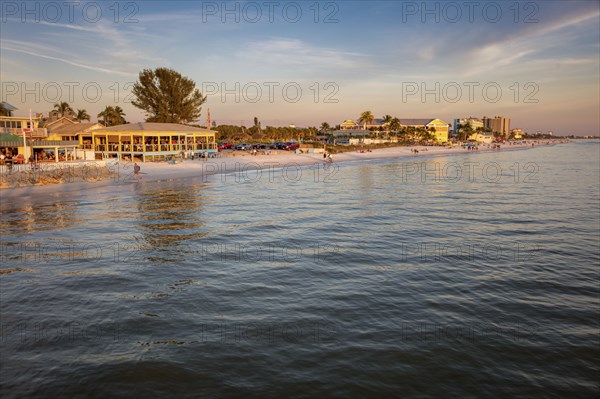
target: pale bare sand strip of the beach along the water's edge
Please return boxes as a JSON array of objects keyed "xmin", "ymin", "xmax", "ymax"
[{"xmin": 0, "ymin": 141, "xmax": 561, "ymax": 200}]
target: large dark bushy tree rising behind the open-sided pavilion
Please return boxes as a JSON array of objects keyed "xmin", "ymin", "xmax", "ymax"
[{"xmin": 131, "ymin": 68, "xmax": 206, "ymax": 123}]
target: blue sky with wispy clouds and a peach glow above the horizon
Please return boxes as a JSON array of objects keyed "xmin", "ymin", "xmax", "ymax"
[{"xmin": 0, "ymin": 0, "xmax": 600, "ymax": 135}]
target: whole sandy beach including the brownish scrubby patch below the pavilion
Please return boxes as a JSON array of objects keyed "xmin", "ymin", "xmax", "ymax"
[{"xmin": 0, "ymin": 140, "xmax": 565, "ymax": 201}]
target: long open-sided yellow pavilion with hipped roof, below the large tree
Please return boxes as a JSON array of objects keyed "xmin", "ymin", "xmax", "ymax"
[{"xmin": 91, "ymin": 122, "xmax": 217, "ymax": 162}]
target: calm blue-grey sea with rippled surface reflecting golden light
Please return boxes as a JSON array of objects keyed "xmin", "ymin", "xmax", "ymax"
[{"xmin": 0, "ymin": 141, "xmax": 600, "ymax": 398}]
